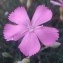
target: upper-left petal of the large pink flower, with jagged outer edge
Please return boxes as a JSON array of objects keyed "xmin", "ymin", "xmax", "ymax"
[{"xmin": 8, "ymin": 7, "xmax": 30, "ymax": 25}]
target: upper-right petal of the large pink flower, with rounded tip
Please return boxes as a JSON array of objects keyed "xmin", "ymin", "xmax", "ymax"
[{"xmin": 32, "ymin": 5, "xmax": 52, "ymax": 26}]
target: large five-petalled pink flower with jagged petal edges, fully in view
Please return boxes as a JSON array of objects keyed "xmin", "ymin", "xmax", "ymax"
[{"xmin": 3, "ymin": 5, "xmax": 59, "ymax": 56}]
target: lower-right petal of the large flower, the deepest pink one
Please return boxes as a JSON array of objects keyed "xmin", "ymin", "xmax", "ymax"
[{"xmin": 35, "ymin": 27, "xmax": 59, "ymax": 46}]
